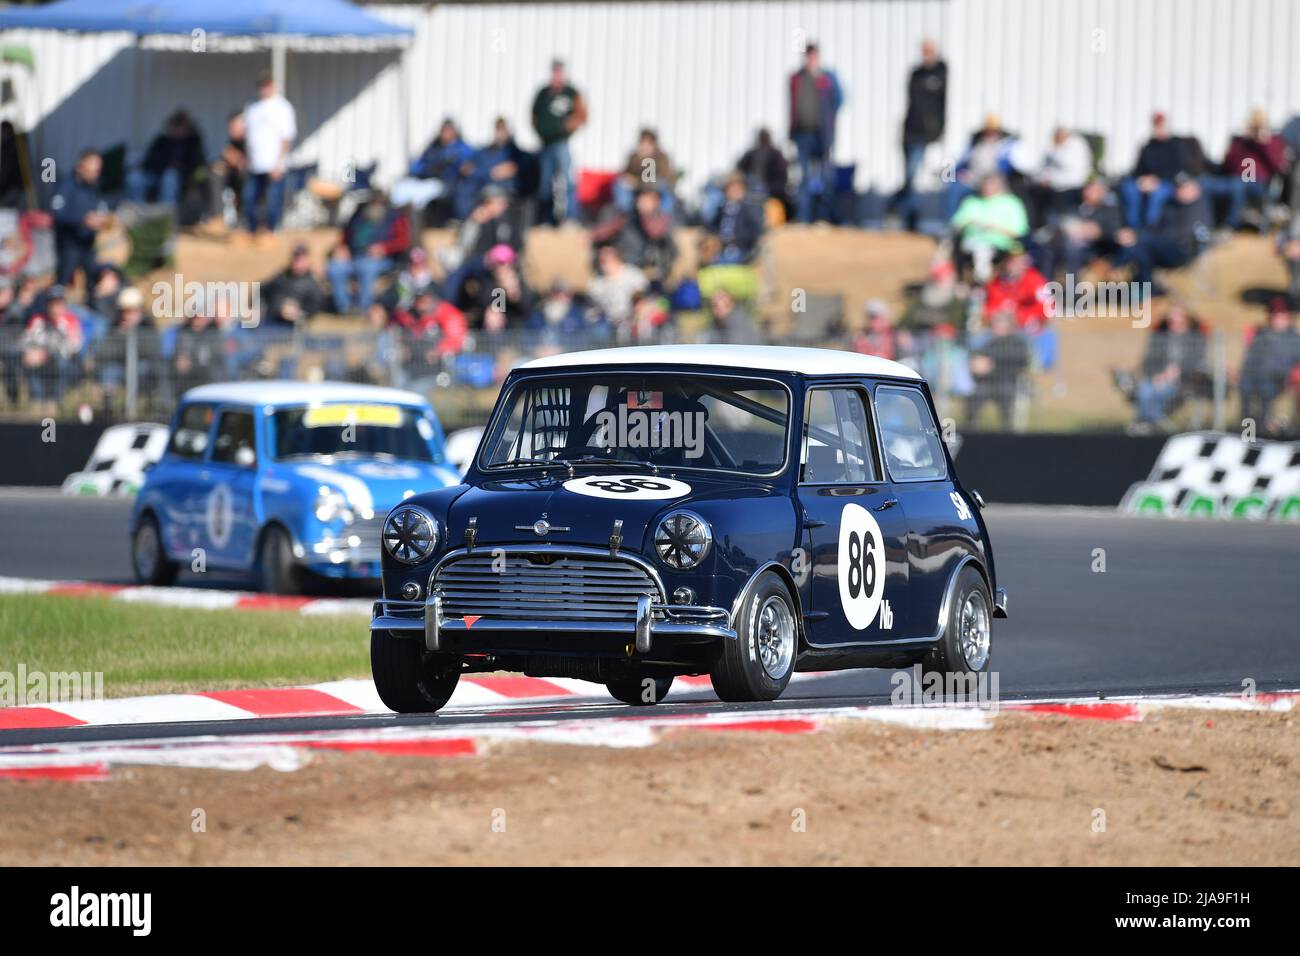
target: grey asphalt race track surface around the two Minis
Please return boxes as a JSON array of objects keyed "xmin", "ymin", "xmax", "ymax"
[{"xmin": 0, "ymin": 490, "xmax": 1300, "ymax": 745}]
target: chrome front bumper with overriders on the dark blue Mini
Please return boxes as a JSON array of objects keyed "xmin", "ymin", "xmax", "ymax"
[{"xmin": 371, "ymin": 594, "xmax": 736, "ymax": 654}]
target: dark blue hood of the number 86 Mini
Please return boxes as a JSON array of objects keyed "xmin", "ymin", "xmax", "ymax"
[{"xmin": 447, "ymin": 468, "xmax": 772, "ymax": 550}]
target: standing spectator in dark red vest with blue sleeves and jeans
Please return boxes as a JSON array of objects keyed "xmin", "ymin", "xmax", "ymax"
[{"xmin": 789, "ymin": 43, "xmax": 844, "ymax": 222}]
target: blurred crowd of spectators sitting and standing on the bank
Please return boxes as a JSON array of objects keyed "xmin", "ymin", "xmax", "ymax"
[{"xmin": 0, "ymin": 40, "xmax": 1300, "ymax": 429}]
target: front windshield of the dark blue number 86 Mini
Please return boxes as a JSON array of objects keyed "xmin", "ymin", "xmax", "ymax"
[{"xmin": 481, "ymin": 372, "xmax": 789, "ymax": 475}]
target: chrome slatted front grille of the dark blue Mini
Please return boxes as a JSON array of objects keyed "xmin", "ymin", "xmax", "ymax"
[{"xmin": 433, "ymin": 548, "xmax": 663, "ymax": 623}]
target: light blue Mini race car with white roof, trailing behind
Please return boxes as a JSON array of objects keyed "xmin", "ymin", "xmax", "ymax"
[{"xmin": 130, "ymin": 381, "xmax": 460, "ymax": 593}]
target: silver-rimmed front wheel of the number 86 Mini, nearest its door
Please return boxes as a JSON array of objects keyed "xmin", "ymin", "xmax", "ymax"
[{"xmin": 710, "ymin": 571, "xmax": 800, "ymax": 701}]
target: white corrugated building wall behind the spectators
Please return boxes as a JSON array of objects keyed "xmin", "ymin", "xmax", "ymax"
[{"xmin": 7, "ymin": 0, "xmax": 1300, "ymax": 200}]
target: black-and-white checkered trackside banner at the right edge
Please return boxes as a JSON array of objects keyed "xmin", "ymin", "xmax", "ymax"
[{"xmin": 1119, "ymin": 432, "xmax": 1300, "ymax": 522}]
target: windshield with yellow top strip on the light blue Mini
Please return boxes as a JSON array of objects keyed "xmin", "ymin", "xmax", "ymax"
[{"xmin": 274, "ymin": 405, "xmax": 441, "ymax": 462}]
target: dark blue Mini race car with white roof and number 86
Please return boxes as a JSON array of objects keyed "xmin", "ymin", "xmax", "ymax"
[{"xmin": 371, "ymin": 346, "xmax": 1006, "ymax": 713}]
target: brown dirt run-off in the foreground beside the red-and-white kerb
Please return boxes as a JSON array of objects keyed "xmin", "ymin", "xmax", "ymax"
[{"xmin": 0, "ymin": 710, "xmax": 1300, "ymax": 865}]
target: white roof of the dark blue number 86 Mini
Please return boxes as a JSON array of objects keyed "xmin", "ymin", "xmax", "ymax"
[{"xmin": 521, "ymin": 345, "xmax": 920, "ymax": 380}]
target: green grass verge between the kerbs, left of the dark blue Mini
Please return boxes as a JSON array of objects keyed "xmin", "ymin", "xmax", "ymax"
[{"xmin": 0, "ymin": 594, "xmax": 371, "ymax": 697}]
